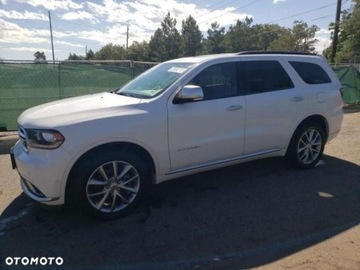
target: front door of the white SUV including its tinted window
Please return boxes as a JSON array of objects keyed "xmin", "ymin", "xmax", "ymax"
[{"xmin": 168, "ymin": 63, "xmax": 246, "ymax": 171}]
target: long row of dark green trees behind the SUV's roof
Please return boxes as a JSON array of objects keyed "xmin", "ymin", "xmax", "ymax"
[{"xmin": 69, "ymin": 13, "xmax": 324, "ymax": 62}]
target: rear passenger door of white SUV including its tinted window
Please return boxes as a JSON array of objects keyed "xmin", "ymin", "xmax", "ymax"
[{"xmin": 238, "ymin": 60, "xmax": 306, "ymax": 154}]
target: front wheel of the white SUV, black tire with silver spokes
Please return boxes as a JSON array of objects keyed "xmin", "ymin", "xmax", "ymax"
[{"xmin": 73, "ymin": 149, "xmax": 150, "ymax": 220}]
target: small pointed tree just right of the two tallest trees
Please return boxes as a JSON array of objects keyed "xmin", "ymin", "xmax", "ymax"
[{"xmin": 204, "ymin": 22, "xmax": 225, "ymax": 54}]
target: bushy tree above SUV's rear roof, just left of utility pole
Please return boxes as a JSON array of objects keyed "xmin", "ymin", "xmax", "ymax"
[{"xmin": 269, "ymin": 21, "xmax": 319, "ymax": 53}]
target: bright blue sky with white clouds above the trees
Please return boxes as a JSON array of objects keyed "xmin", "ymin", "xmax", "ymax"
[{"xmin": 0, "ymin": 0, "xmax": 352, "ymax": 60}]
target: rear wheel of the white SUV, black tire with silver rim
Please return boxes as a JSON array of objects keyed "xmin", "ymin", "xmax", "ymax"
[{"xmin": 286, "ymin": 122, "xmax": 325, "ymax": 169}]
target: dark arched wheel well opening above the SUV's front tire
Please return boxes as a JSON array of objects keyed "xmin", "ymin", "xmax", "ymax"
[{"xmin": 65, "ymin": 142, "xmax": 156, "ymax": 203}]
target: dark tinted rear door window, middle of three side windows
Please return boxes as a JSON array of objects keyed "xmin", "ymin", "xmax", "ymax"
[{"xmin": 238, "ymin": 61, "xmax": 294, "ymax": 94}]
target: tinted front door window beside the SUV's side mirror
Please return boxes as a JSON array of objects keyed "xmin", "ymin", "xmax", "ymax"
[{"xmin": 189, "ymin": 63, "xmax": 237, "ymax": 100}]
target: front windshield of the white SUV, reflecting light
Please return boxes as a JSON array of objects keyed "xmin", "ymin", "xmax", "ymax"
[{"xmin": 116, "ymin": 63, "xmax": 194, "ymax": 98}]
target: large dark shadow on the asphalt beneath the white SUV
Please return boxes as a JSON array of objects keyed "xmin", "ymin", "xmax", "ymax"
[{"xmin": 0, "ymin": 156, "xmax": 360, "ymax": 269}]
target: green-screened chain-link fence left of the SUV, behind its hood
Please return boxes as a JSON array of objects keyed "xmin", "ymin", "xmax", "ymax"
[{"xmin": 0, "ymin": 60, "xmax": 157, "ymax": 131}]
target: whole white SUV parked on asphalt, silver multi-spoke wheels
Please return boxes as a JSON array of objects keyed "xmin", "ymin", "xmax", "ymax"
[{"xmin": 11, "ymin": 52, "xmax": 343, "ymax": 218}]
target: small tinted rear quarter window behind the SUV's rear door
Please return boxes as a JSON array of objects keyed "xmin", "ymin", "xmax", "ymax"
[{"xmin": 290, "ymin": 62, "xmax": 331, "ymax": 84}]
